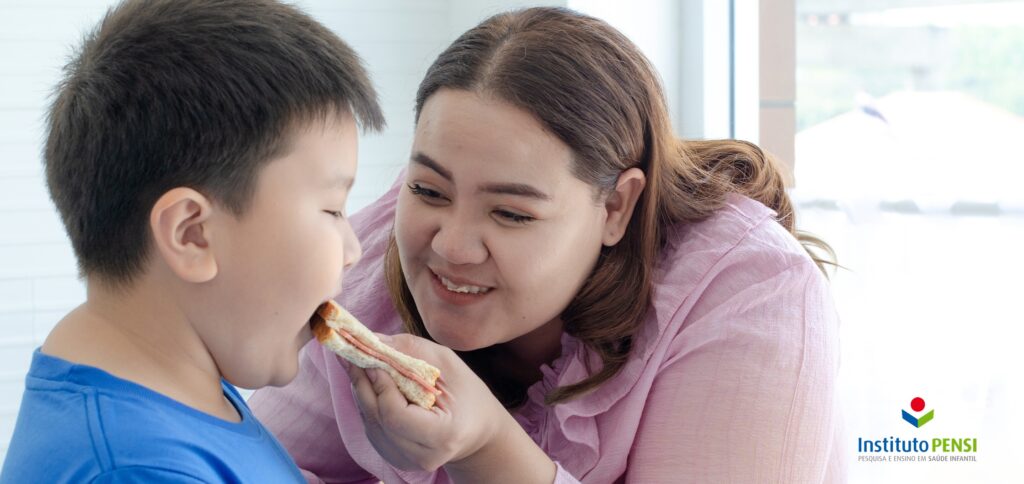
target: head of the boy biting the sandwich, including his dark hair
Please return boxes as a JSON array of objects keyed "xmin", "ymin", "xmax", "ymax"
[{"xmin": 45, "ymin": 0, "xmax": 384, "ymax": 387}]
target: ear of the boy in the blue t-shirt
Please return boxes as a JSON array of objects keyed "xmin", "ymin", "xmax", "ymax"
[{"xmin": 150, "ymin": 187, "xmax": 217, "ymax": 283}]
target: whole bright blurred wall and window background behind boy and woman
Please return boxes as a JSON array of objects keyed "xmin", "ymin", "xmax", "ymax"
[{"xmin": 0, "ymin": 0, "xmax": 1024, "ymax": 482}]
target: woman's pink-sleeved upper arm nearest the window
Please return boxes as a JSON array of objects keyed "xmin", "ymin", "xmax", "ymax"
[{"xmin": 627, "ymin": 261, "xmax": 842, "ymax": 483}]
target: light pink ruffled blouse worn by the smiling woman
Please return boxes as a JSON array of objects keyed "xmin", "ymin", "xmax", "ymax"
[{"xmin": 250, "ymin": 178, "xmax": 847, "ymax": 483}]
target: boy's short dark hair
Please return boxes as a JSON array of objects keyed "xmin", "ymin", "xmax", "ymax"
[{"xmin": 44, "ymin": 0, "xmax": 384, "ymax": 285}]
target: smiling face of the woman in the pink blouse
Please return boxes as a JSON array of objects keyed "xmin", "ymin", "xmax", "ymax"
[{"xmin": 395, "ymin": 89, "xmax": 606, "ymax": 351}]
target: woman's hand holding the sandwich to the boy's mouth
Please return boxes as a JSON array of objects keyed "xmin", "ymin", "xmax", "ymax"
[{"xmin": 343, "ymin": 335, "xmax": 512, "ymax": 470}]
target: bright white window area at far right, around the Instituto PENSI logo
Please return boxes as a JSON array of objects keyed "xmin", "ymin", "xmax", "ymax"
[{"xmin": 793, "ymin": 0, "xmax": 1024, "ymax": 482}]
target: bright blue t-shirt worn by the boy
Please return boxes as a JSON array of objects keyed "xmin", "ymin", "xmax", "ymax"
[{"xmin": 0, "ymin": 349, "xmax": 305, "ymax": 484}]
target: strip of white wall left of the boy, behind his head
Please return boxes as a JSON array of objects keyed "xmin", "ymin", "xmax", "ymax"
[{"xmin": 0, "ymin": 0, "xmax": 115, "ymax": 464}]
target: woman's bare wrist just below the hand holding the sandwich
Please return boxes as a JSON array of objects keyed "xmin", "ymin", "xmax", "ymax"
[{"xmin": 444, "ymin": 413, "xmax": 557, "ymax": 484}]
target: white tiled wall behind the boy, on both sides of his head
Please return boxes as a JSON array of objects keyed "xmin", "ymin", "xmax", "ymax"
[{"xmin": 0, "ymin": 0, "xmax": 684, "ymax": 468}]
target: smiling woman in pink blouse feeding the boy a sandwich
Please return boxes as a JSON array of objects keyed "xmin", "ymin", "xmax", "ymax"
[{"xmin": 252, "ymin": 8, "xmax": 843, "ymax": 482}]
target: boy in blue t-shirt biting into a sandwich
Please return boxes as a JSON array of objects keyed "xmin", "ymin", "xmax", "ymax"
[{"xmin": 0, "ymin": 0, "xmax": 384, "ymax": 483}]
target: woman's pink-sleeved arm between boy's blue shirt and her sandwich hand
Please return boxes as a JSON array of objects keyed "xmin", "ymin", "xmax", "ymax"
[{"xmin": 249, "ymin": 346, "xmax": 378, "ymax": 483}]
